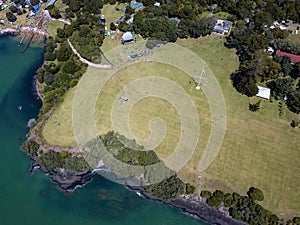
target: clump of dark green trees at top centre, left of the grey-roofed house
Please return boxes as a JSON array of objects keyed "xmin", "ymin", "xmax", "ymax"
[{"xmin": 132, "ymin": 1, "xmax": 215, "ymax": 42}]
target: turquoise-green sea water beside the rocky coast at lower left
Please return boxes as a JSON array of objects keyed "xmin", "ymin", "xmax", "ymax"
[{"xmin": 0, "ymin": 36, "xmax": 209, "ymax": 225}]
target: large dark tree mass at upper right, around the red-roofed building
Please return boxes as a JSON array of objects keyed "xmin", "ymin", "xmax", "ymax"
[{"xmin": 223, "ymin": 0, "xmax": 300, "ymax": 113}]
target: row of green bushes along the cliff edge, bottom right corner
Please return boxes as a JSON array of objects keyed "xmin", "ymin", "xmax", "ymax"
[{"xmin": 200, "ymin": 187, "xmax": 300, "ymax": 225}]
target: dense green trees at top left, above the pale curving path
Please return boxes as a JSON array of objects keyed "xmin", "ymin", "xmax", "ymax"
[{"xmin": 48, "ymin": 0, "xmax": 105, "ymax": 63}]
